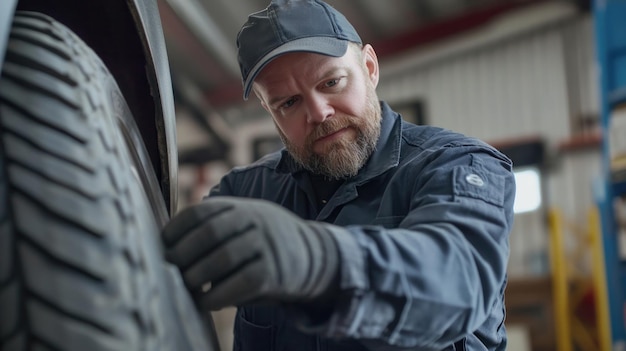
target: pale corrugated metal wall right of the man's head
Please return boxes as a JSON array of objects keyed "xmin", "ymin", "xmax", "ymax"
[{"xmin": 378, "ymin": 18, "xmax": 593, "ymax": 141}]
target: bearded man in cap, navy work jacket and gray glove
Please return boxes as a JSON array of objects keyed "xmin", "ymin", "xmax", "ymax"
[{"xmin": 163, "ymin": 0, "xmax": 515, "ymax": 351}]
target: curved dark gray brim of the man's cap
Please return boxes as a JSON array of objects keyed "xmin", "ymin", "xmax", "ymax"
[{"xmin": 243, "ymin": 37, "xmax": 348, "ymax": 100}]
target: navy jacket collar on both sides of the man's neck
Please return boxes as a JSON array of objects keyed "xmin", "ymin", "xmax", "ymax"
[{"xmin": 276, "ymin": 101, "xmax": 402, "ymax": 184}]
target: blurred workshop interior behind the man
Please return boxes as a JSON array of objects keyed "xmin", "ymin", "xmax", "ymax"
[{"xmin": 159, "ymin": 0, "xmax": 626, "ymax": 351}]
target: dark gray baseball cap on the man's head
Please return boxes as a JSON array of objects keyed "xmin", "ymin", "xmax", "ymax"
[{"xmin": 237, "ymin": 0, "xmax": 362, "ymax": 100}]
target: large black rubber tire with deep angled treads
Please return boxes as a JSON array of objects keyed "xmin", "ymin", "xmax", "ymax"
[{"xmin": 0, "ymin": 13, "xmax": 215, "ymax": 351}]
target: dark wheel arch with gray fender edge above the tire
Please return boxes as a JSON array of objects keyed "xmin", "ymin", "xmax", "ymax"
[{"xmin": 0, "ymin": 0, "xmax": 178, "ymax": 215}]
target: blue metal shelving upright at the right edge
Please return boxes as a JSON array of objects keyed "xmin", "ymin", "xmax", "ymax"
[{"xmin": 593, "ymin": 0, "xmax": 626, "ymax": 350}]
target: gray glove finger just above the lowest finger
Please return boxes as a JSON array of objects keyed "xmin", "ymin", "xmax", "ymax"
[{"xmin": 183, "ymin": 230, "xmax": 262, "ymax": 291}]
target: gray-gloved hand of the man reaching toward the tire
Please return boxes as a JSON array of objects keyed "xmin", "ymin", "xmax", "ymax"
[{"xmin": 158, "ymin": 197, "xmax": 343, "ymax": 310}]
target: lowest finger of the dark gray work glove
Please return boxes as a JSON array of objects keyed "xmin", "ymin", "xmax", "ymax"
[{"xmin": 199, "ymin": 260, "xmax": 270, "ymax": 310}]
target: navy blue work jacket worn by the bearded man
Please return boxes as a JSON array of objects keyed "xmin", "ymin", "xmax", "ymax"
[{"xmin": 209, "ymin": 102, "xmax": 515, "ymax": 351}]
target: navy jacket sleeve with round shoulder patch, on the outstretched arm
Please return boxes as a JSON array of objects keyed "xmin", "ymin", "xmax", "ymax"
[{"xmin": 296, "ymin": 146, "xmax": 515, "ymax": 350}]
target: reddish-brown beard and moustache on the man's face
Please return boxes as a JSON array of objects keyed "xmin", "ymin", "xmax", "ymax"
[{"xmin": 277, "ymin": 82, "xmax": 382, "ymax": 179}]
